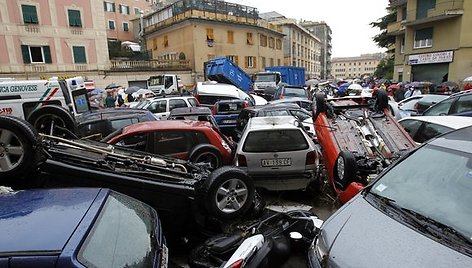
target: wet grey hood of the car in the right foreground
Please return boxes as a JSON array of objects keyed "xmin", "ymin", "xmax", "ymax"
[{"xmin": 321, "ymin": 195, "xmax": 472, "ymax": 267}]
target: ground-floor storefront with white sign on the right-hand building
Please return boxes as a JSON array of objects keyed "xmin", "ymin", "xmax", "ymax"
[{"xmin": 408, "ymin": 51, "xmax": 454, "ymax": 84}]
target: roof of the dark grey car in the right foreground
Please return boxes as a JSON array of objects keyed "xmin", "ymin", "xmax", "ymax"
[{"xmin": 427, "ymin": 126, "xmax": 472, "ymax": 154}]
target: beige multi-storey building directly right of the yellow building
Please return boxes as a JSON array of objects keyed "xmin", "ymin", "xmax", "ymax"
[{"xmin": 261, "ymin": 12, "xmax": 321, "ymax": 79}]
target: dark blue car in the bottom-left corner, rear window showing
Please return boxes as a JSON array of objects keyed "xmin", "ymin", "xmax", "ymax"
[{"xmin": 0, "ymin": 188, "xmax": 168, "ymax": 267}]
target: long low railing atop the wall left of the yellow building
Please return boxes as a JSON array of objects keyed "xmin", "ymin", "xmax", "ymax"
[{"xmin": 110, "ymin": 60, "xmax": 190, "ymax": 72}]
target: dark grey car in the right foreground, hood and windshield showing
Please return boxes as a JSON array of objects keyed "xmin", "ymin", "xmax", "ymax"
[{"xmin": 308, "ymin": 127, "xmax": 472, "ymax": 267}]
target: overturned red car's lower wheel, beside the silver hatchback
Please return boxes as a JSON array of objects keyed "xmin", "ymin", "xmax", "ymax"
[{"xmin": 334, "ymin": 151, "xmax": 357, "ymax": 190}]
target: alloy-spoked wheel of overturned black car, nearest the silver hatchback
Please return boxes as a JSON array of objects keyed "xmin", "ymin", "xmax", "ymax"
[{"xmin": 201, "ymin": 166, "xmax": 255, "ymax": 221}]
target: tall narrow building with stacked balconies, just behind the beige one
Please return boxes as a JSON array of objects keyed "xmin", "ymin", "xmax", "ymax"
[{"xmin": 300, "ymin": 21, "xmax": 332, "ymax": 79}]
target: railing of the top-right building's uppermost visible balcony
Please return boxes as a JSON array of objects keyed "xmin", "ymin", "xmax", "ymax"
[{"xmin": 407, "ymin": 0, "xmax": 464, "ymax": 23}]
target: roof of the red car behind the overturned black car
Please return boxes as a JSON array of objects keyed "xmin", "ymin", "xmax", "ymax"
[{"xmin": 121, "ymin": 120, "xmax": 212, "ymax": 134}]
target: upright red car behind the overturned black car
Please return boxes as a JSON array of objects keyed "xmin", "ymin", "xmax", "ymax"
[{"xmin": 102, "ymin": 120, "xmax": 233, "ymax": 169}]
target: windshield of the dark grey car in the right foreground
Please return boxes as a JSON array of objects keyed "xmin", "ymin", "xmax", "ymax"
[{"xmin": 370, "ymin": 145, "xmax": 472, "ymax": 242}]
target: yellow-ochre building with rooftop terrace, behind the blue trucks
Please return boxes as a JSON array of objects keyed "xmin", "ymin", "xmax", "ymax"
[{"xmin": 144, "ymin": 0, "xmax": 284, "ymax": 81}]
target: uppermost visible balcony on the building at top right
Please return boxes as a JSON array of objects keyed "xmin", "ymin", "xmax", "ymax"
[{"xmin": 404, "ymin": 0, "xmax": 464, "ymax": 26}]
